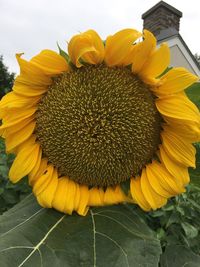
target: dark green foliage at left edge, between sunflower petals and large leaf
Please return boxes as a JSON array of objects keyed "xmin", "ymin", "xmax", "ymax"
[{"xmin": 0, "ymin": 138, "xmax": 31, "ymax": 214}]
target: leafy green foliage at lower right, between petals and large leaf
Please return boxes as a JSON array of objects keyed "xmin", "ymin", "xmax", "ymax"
[{"xmin": 147, "ymin": 185, "xmax": 200, "ymax": 254}]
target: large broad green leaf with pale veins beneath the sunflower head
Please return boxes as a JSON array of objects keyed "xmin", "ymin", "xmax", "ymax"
[{"xmin": 0, "ymin": 195, "xmax": 161, "ymax": 267}]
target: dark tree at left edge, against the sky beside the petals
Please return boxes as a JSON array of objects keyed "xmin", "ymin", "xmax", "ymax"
[{"xmin": 0, "ymin": 55, "xmax": 15, "ymax": 99}]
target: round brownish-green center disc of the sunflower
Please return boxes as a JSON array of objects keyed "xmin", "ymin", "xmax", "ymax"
[{"xmin": 36, "ymin": 65, "xmax": 161, "ymax": 186}]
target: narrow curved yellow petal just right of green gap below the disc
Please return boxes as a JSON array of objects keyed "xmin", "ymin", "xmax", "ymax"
[{"xmin": 130, "ymin": 177, "xmax": 151, "ymax": 211}]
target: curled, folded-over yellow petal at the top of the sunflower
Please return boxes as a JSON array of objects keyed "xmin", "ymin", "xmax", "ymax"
[{"xmin": 68, "ymin": 30, "xmax": 104, "ymax": 68}]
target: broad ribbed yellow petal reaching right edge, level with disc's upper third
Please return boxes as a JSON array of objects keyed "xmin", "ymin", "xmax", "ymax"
[{"xmin": 156, "ymin": 93, "xmax": 200, "ymax": 124}]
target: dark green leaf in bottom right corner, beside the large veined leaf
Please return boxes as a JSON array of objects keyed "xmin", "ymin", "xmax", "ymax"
[{"xmin": 160, "ymin": 245, "xmax": 200, "ymax": 267}]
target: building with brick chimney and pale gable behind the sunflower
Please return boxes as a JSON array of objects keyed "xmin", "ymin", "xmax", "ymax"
[{"xmin": 142, "ymin": 1, "xmax": 200, "ymax": 76}]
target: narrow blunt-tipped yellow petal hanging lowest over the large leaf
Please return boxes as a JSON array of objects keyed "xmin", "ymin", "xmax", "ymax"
[{"xmin": 76, "ymin": 185, "xmax": 89, "ymax": 216}]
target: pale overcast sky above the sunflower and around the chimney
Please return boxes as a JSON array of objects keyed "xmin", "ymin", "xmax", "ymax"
[{"xmin": 0, "ymin": 0, "xmax": 200, "ymax": 73}]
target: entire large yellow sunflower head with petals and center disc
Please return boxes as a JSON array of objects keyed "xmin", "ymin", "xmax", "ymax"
[{"xmin": 0, "ymin": 29, "xmax": 200, "ymax": 215}]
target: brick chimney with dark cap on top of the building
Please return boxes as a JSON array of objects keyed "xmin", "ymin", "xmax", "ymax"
[{"xmin": 142, "ymin": 1, "xmax": 182, "ymax": 36}]
